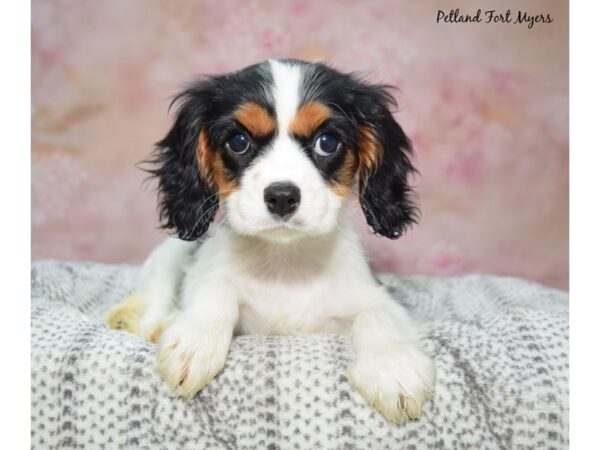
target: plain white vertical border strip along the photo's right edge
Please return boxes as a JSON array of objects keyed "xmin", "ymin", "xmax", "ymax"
[{"xmin": 569, "ymin": 0, "xmax": 600, "ymax": 449}]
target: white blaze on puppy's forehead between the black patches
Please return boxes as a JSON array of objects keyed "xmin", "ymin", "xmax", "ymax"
[{"xmin": 269, "ymin": 60, "xmax": 302, "ymax": 131}]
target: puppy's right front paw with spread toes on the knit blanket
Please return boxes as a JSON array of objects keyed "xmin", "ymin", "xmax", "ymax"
[{"xmin": 348, "ymin": 344, "xmax": 435, "ymax": 423}]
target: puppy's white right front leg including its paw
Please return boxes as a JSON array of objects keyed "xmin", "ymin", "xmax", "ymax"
[{"xmin": 348, "ymin": 287, "xmax": 435, "ymax": 423}]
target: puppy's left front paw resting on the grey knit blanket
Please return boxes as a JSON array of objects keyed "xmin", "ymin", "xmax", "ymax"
[{"xmin": 158, "ymin": 318, "xmax": 232, "ymax": 398}]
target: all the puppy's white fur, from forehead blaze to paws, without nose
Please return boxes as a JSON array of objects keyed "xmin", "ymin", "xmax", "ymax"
[{"xmin": 127, "ymin": 61, "xmax": 435, "ymax": 422}]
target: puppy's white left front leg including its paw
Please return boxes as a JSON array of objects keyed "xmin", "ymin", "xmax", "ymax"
[{"xmin": 158, "ymin": 274, "xmax": 238, "ymax": 398}]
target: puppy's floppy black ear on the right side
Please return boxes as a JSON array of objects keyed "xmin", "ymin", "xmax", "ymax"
[{"xmin": 355, "ymin": 85, "xmax": 419, "ymax": 239}]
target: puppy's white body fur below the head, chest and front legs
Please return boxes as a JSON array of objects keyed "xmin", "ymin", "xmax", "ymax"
[{"xmin": 138, "ymin": 213, "xmax": 435, "ymax": 422}]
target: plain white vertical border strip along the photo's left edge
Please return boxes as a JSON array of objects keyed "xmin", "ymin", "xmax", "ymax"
[{"xmin": 0, "ymin": 1, "xmax": 31, "ymax": 448}]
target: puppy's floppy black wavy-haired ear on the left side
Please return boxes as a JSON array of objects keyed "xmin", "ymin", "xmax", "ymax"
[{"xmin": 148, "ymin": 81, "xmax": 219, "ymax": 241}]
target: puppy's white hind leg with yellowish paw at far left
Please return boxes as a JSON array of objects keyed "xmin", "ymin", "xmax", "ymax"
[{"xmin": 107, "ymin": 237, "xmax": 197, "ymax": 342}]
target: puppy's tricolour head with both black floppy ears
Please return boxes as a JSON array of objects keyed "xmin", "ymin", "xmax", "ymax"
[{"xmin": 152, "ymin": 60, "xmax": 416, "ymax": 242}]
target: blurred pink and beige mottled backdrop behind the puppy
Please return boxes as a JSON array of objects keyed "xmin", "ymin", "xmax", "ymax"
[{"xmin": 32, "ymin": 0, "xmax": 569, "ymax": 289}]
